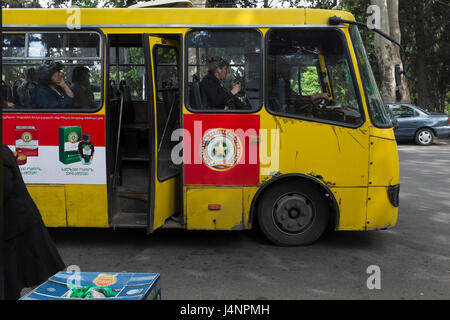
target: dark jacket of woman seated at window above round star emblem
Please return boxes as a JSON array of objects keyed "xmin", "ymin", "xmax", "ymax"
[{"xmin": 200, "ymin": 72, "xmax": 233, "ymax": 109}]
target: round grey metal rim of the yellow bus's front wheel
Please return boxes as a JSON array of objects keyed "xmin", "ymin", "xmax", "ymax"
[{"xmin": 272, "ymin": 193, "xmax": 315, "ymax": 234}]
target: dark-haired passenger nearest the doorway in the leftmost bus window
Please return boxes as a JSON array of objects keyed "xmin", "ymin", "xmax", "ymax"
[{"xmin": 70, "ymin": 67, "xmax": 97, "ymax": 109}]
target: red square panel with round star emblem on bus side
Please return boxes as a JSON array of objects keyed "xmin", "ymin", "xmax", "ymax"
[{"xmin": 183, "ymin": 114, "xmax": 260, "ymax": 186}]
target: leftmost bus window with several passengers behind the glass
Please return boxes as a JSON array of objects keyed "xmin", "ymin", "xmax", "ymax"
[{"xmin": 2, "ymin": 32, "xmax": 102, "ymax": 112}]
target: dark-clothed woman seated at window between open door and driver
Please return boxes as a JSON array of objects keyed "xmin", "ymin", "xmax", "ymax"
[{"xmin": 200, "ymin": 57, "xmax": 241, "ymax": 109}]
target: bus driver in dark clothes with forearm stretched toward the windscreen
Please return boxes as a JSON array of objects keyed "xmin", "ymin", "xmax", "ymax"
[{"xmin": 275, "ymin": 64, "xmax": 329, "ymax": 112}]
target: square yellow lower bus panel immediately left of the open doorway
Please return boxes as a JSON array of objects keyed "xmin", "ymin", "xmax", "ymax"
[{"xmin": 65, "ymin": 185, "xmax": 109, "ymax": 228}]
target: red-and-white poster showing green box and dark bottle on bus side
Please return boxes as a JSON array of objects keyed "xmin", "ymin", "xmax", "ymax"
[{"xmin": 3, "ymin": 114, "xmax": 106, "ymax": 184}]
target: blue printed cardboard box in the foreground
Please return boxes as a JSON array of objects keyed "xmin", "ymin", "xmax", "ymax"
[{"xmin": 20, "ymin": 272, "xmax": 161, "ymax": 300}]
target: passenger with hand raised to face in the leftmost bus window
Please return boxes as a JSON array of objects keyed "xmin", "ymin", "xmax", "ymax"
[{"xmin": 31, "ymin": 61, "xmax": 74, "ymax": 109}]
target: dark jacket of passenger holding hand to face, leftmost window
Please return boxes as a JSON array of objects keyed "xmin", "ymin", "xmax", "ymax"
[{"xmin": 31, "ymin": 84, "xmax": 73, "ymax": 109}]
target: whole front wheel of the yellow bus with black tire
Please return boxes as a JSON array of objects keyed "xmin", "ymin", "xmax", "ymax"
[{"xmin": 258, "ymin": 180, "xmax": 330, "ymax": 246}]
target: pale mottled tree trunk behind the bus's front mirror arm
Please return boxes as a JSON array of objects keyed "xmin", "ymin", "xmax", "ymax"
[{"xmin": 370, "ymin": 0, "xmax": 410, "ymax": 103}]
